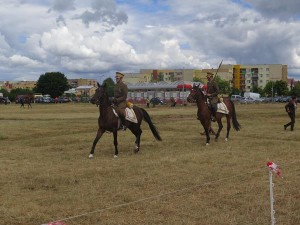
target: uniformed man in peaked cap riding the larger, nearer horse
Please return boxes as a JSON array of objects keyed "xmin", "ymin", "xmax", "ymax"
[{"xmin": 112, "ymin": 72, "xmax": 128, "ymax": 130}]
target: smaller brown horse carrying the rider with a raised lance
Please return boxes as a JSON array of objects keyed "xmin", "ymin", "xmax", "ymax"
[{"xmin": 187, "ymin": 84, "xmax": 241, "ymax": 145}]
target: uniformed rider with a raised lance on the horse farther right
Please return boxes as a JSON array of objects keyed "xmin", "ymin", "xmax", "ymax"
[{"xmin": 206, "ymin": 72, "xmax": 219, "ymax": 122}]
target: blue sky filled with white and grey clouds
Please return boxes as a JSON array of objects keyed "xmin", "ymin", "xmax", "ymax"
[{"xmin": 0, "ymin": 0, "xmax": 300, "ymax": 82}]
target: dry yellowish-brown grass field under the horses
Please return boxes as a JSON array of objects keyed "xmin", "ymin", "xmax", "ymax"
[{"xmin": 0, "ymin": 103, "xmax": 300, "ymax": 225}]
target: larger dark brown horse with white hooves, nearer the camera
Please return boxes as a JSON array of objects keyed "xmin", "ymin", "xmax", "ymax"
[{"xmin": 89, "ymin": 83, "xmax": 162, "ymax": 158}]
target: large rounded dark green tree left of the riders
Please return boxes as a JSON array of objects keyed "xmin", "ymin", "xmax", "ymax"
[{"xmin": 34, "ymin": 72, "xmax": 70, "ymax": 98}]
